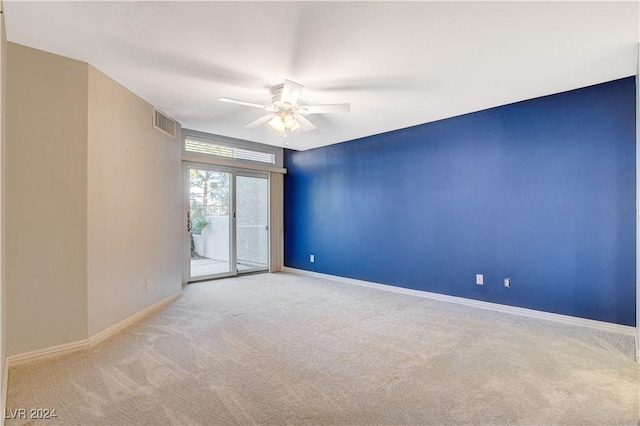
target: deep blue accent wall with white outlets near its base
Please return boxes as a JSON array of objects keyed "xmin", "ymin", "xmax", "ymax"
[{"xmin": 284, "ymin": 77, "xmax": 636, "ymax": 325}]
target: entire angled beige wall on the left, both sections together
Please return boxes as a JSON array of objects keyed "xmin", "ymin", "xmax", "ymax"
[{"xmin": 5, "ymin": 43, "xmax": 182, "ymax": 356}]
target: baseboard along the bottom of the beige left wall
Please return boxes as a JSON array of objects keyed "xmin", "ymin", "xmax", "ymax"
[{"xmin": 3, "ymin": 290, "xmax": 182, "ymax": 368}]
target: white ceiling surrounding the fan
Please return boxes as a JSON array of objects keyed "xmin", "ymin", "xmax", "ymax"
[{"xmin": 4, "ymin": 0, "xmax": 640, "ymax": 149}]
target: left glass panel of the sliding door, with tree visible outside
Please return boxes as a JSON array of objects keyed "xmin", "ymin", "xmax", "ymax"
[{"xmin": 188, "ymin": 165, "xmax": 235, "ymax": 281}]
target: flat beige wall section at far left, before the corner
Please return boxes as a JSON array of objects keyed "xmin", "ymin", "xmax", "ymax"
[{"xmin": 5, "ymin": 43, "xmax": 88, "ymax": 355}]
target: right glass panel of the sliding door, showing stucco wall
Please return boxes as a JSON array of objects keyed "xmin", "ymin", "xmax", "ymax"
[{"xmin": 236, "ymin": 174, "xmax": 269, "ymax": 273}]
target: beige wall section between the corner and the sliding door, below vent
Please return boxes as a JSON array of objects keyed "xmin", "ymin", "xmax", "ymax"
[{"xmin": 88, "ymin": 66, "xmax": 182, "ymax": 336}]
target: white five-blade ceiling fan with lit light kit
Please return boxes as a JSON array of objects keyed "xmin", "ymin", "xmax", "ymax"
[{"xmin": 218, "ymin": 80, "xmax": 351, "ymax": 137}]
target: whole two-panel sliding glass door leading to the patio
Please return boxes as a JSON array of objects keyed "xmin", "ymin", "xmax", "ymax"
[{"xmin": 184, "ymin": 163, "xmax": 269, "ymax": 281}]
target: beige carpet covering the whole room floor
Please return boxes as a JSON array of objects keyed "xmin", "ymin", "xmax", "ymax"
[{"xmin": 7, "ymin": 273, "xmax": 639, "ymax": 425}]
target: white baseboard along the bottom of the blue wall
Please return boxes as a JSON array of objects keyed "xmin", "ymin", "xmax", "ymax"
[{"xmin": 282, "ymin": 266, "xmax": 640, "ymax": 338}]
